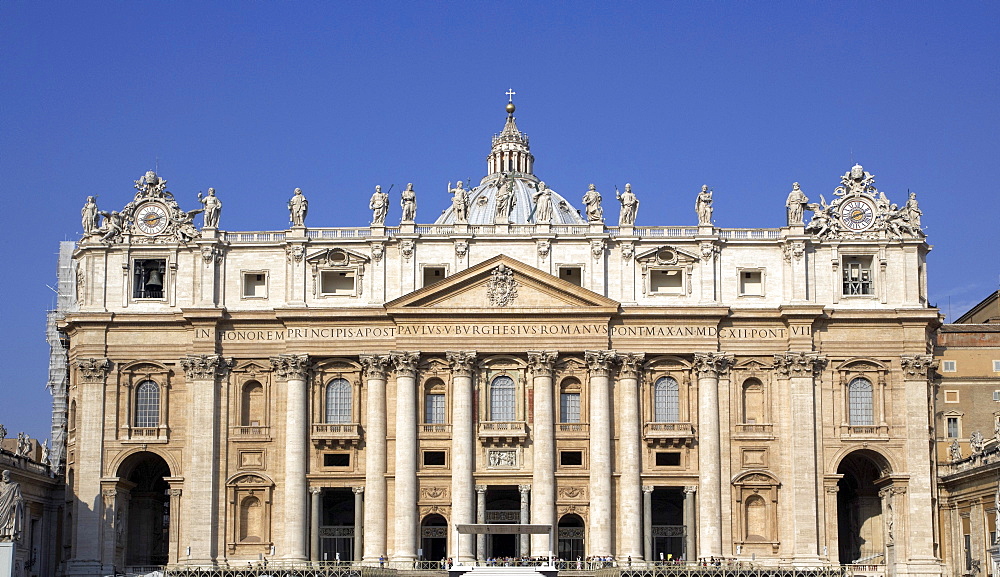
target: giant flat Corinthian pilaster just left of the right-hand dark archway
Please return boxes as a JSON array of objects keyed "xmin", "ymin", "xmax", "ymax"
[{"xmin": 774, "ymin": 351, "xmax": 826, "ymax": 562}]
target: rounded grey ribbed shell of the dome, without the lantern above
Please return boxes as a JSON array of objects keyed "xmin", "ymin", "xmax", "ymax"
[{"xmin": 434, "ymin": 174, "xmax": 587, "ymax": 225}]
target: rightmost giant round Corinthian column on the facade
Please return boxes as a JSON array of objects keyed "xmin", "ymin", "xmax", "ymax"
[{"xmin": 694, "ymin": 353, "xmax": 732, "ymax": 557}]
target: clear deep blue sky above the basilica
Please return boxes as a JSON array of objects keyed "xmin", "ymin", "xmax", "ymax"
[{"xmin": 0, "ymin": 1, "xmax": 1000, "ymax": 438}]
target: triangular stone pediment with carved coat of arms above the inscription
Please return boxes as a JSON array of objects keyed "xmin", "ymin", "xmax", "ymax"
[{"xmin": 385, "ymin": 255, "xmax": 618, "ymax": 313}]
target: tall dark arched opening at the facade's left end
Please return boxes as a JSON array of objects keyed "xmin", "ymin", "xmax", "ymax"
[{"xmin": 115, "ymin": 451, "xmax": 170, "ymax": 566}]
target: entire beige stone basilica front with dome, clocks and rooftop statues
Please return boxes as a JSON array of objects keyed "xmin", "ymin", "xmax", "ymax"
[{"xmin": 61, "ymin": 105, "xmax": 942, "ymax": 575}]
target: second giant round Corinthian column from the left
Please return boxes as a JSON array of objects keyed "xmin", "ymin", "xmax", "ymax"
[{"xmin": 355, "ymin": 355, "xmax": 389, "ymax": 565}]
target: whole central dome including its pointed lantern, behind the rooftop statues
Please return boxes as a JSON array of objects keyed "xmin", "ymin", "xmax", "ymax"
[{"xmin": 434, "ymin": 102, "xmax": 587, "ymax": 225}]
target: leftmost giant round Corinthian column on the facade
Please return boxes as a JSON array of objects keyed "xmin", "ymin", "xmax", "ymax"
[{"xmin": 272, "ymin": 355, "xmax": 309, "ymax": 561}]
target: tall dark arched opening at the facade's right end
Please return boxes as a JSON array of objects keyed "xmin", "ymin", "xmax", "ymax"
[{"xmin": 837, "ymin": 450, "xmax": 889, "ymax": 564}]
